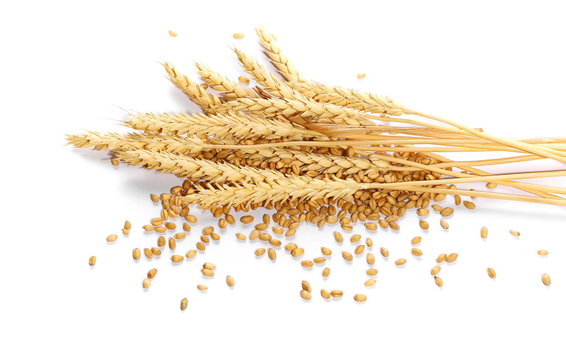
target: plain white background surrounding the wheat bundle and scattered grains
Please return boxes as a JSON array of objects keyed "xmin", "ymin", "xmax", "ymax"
[{"xmin": 0, "ymin": 1, "xmax": 566, "ymax": 359}]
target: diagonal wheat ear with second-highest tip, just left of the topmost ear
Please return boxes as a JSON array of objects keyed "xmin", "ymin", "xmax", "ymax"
[{"xmin": 234, "ymin": 49, "xmax": 309, "ymax": 101}]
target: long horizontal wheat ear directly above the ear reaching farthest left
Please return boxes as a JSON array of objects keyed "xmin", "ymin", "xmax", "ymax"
[{"xmin": 124, "ymin": 113, "xmax": 329, "ymax": 140}]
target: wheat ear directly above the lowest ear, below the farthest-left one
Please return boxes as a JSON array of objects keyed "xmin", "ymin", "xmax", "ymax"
[{"xmin": 116, "ymin": 150, "xmax": 285, "ymax": 183}]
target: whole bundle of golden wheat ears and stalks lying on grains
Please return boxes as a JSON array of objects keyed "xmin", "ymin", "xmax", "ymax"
[{"xmin": 67, "ymin": 29, "xmax": 566, "ymax": 228}]
